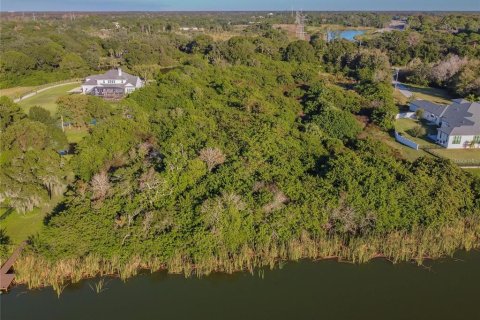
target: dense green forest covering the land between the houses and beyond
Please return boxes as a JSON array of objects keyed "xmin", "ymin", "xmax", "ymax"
[{"xmin": 0, "ymin": 14, "xmax": 480, "ymax": 290}]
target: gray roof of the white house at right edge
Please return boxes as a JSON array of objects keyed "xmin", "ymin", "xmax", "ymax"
[{"xmin": 439, "ymin": 100, "xmax": 480, "ymax": 135}]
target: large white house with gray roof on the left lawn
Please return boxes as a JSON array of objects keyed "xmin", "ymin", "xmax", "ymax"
[{"xmin": 82, "ymin": 68, "xmax": 144, "ymax": 99}]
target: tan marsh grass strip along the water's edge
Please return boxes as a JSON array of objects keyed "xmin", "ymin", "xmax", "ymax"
[{"xmin": 15, "ymin": 219, "xmax": 480, "ymax": 294}]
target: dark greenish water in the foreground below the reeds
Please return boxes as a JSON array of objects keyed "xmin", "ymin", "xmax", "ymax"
[{"xmin": 0, "ymin": 251, "xmax": 480, "ymax": 320}]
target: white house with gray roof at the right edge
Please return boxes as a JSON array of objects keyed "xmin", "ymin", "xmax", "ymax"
[{"xmin": 410, "ymin": 99, "xmax": 480, "ymax": 149}]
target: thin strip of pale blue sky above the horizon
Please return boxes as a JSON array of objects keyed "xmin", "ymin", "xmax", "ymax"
[{"xmin": 0, "ymin": 0, "xmax": 480, "ymax": 11}]
